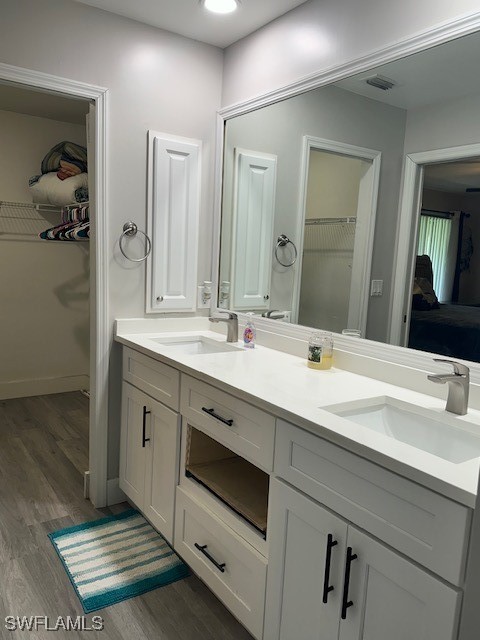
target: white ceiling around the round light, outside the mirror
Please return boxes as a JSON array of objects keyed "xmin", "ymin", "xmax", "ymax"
[{"xmin": 76, "ymin": 0, "xmax": 306, "ymax": 48}]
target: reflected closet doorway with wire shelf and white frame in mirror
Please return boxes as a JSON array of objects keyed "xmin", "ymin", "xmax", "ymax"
[{"xmin": 294, "ymin": 137, "xmax": 380, "ymax": 335}]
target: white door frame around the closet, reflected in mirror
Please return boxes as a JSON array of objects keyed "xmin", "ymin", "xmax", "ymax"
[{"xmin": 292, "ymin": 135, "xmax": 382, "ymax": 336}]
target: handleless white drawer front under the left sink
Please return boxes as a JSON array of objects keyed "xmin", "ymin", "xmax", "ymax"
[{"xmin": 123, "ymin": 347, "xmax": 180, "ymax": 411}]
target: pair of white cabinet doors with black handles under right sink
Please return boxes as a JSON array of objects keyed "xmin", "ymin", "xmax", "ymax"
[{"xmin": 264, "ymin": 479, "xmax": 460, "ymax": 640}]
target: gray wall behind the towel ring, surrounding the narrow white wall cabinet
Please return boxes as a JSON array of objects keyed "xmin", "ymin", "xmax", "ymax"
[{"xmin": 0, "ymin": 0, "xmax": 223, "ymax": 478}]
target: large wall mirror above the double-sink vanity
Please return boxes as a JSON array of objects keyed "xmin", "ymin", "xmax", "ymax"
[{"xmin": 218, "ymin": 34, "xmax": 480, "ymax": 362}]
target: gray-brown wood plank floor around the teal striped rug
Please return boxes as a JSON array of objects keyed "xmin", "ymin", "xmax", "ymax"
[{"xmin": 0, "ymin": 393, "xmax": 251, "ymax": 640}]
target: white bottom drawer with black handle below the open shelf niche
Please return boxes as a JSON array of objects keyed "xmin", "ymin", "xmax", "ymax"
[{"xmin": 175, "ymin": 487, "xmax": 267, "ymax": 638}]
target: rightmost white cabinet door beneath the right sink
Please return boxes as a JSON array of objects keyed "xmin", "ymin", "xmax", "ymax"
[{"xmin": 340, "ymin": 527, "xmax": 460, "ymax": 640}]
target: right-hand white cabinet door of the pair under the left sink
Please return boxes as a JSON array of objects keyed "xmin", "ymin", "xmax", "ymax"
[{"xmin": 144, "ymin": 398, "xmax": 180, "ymax": 544}]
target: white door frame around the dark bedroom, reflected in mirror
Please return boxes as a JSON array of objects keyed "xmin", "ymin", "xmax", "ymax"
[{"xmin": 389, "ymin": 143, "xmax": 480, "ymax": 346}]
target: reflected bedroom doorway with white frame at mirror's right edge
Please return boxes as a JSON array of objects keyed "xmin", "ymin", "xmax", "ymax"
[{"xmin": 390, "ymin": 144, "xmax": 480, "ymax": 362}]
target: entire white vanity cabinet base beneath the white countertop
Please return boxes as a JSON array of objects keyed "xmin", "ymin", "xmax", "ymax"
[{"xmin": 120, "ymin": 347, "xmax": 472, "ymax": 640}]
